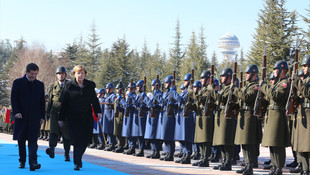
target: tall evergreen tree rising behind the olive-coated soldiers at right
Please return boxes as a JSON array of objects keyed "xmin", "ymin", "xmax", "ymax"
[{"xmin": 247, "ymin": 0, "xmax": 297, "ymax": 71}]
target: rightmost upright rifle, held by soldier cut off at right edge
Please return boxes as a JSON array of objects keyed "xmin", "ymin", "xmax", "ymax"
[{"xmin": 286, "ymin": 38, "xmax": 299, "ymax": 116}]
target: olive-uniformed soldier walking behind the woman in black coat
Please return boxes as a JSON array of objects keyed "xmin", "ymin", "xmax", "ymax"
[{"xmin": 46, "ymin": 66, "xmax": 70, "ymax": 161}]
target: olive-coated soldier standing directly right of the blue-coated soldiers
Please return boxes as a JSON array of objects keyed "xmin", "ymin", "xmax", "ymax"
[{"xmin": 189, "ymin": 70, "xmax": 216, "ymax": 167}]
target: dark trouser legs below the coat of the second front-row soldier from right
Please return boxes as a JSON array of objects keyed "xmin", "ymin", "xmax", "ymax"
[{"xmin": 269, "ymin": 146, "xmax": 286, "ymax": 169}]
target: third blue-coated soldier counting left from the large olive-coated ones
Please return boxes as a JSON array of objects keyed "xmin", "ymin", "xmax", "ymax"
[{"xmin": 144, "ymin": 79, "xmax": 163, "ymax": 159}]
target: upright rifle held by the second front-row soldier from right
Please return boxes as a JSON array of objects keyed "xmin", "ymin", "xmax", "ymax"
[{"xmin": 253, "ymin": 46, "xmax": 267, "ymax": 118}]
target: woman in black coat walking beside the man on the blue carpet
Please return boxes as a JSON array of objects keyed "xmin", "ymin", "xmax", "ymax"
[{"xmin": 59, "ymin": 65, "xmax": 102, "ymax": 170}]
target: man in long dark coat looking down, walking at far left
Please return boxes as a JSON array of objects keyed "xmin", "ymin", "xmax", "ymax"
[{"xmin": 11, "ymin": 63, "xmax": 45, "ymax": 171}]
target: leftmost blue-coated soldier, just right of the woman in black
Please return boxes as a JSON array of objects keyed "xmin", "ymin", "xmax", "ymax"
[{"xmin": 94, "ymin": 88, "xmax": 106, "ymax": 150}]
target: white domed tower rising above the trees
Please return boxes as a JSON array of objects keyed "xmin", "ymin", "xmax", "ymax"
[{"xmin": 218, "ymin": 32, "xmax": 240, "ymax": 61}]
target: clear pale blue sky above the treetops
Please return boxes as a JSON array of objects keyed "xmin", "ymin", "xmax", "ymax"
[{"xmin": 0, "ymin": 0, "xmax": 310, "ymax": 63}]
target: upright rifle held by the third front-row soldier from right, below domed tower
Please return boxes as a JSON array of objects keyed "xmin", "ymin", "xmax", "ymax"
[{"xmin": 225, "ymin": 54, "xmax": 237, "ymax": 119}]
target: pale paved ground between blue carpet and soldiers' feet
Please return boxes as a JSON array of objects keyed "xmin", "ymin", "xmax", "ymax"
[{"xmin": 0, "ymin": 133, "xmax": 293, "ymax": 175}]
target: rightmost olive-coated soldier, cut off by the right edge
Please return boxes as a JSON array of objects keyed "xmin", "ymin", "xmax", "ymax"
[{"xmin": 293, "ymin": 55, "xmax": 310, "ymax": 175}]
